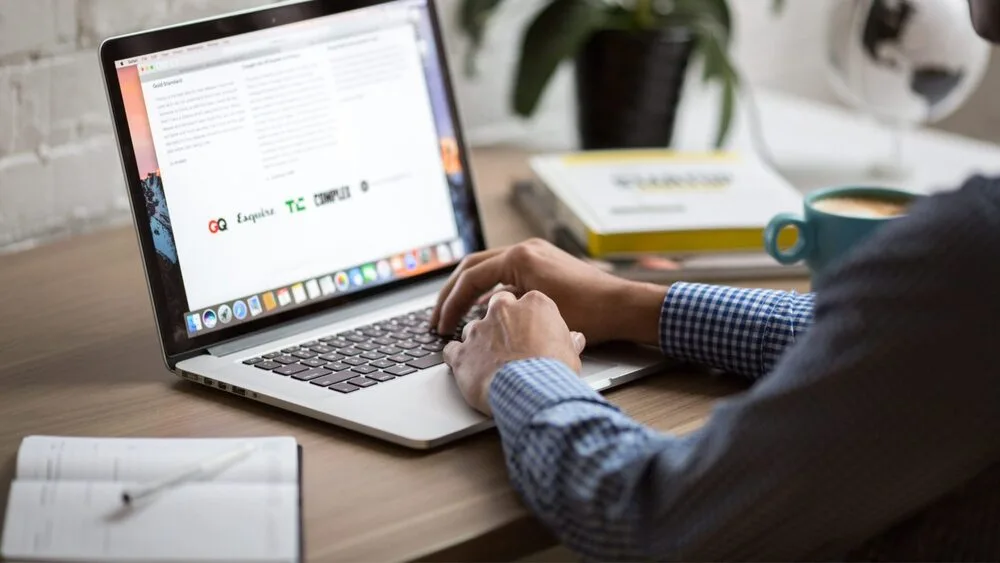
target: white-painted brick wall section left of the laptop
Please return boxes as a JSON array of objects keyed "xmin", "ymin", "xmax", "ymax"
[{"xmin": 0, "ymin": 0, "xmax": 269, "ymax": 251}]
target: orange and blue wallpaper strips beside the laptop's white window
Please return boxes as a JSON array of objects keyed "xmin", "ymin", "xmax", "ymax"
[{"xmin": 118, "ymin": 2, "xmax": 477, "ymax": 350}]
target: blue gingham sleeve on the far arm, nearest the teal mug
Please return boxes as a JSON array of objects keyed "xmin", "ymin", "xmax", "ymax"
[{"xmin": 659, "ymin": 283, "xmax": 814, "ymax": 379}]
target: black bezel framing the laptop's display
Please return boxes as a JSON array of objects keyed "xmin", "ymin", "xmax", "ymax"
[{"xmin": 100, "ymin": 0, "xmax": 485, "ymax": 369}]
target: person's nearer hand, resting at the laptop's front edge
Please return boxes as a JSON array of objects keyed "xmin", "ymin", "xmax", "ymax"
[{"xmin": 444, "ymin": 291, "xmax": 586, "ymax": 415}]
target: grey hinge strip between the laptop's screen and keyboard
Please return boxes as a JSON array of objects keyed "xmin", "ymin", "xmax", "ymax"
[{"xmin": 207, "ymin": 276, "xmax": 447, "ymax": 356}]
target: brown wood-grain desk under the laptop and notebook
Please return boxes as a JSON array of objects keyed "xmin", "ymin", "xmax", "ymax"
[{"xmin": 0, "ymin": 149, "xmax": 804, "ymax": 561}]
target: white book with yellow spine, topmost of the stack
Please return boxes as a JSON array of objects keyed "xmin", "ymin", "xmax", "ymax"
[{"xmin": 530, "ymin": 149, "xmax": 802, "ymax": 258}]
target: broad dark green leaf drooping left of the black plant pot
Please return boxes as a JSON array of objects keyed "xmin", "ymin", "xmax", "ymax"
[{"xmin": 514, "ymin": 0, "xmax": 606, "ymax": 117}]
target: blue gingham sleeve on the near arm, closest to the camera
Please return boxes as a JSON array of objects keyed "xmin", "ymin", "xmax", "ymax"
[{"xmin": 490, "ymin": 360, "xmax": 683, "ymax": 560}]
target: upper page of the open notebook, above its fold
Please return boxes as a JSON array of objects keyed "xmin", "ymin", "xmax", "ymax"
[{"xmin": 17, "ymin": 436, "xmax": 298, "ymax": 483}]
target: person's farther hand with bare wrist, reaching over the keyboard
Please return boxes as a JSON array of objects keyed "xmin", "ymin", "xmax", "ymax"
[{"xmin": 431, "ymin": 239, "xmax": 667, "ymax": 344}]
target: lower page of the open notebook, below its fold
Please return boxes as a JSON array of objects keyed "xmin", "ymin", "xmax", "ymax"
[{"xmin": 2, "ymin": 481, "xmax": 300, "ymax": 563}]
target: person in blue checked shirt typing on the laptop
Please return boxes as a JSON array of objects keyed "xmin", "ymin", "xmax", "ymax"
[{"xmin": 432, "ymin": 0, "xmax": 1000, "ymax": 561}]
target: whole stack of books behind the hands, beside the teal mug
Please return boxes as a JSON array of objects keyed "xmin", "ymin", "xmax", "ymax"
[{"xmin": 511, "ymin": 150, "xmax": 806, "ymax": 283}]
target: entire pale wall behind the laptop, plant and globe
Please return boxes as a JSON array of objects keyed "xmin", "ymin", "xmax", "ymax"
[{"xmin": 0, "ymin": 0, "xmax": 1000, "ymax": 252}]
